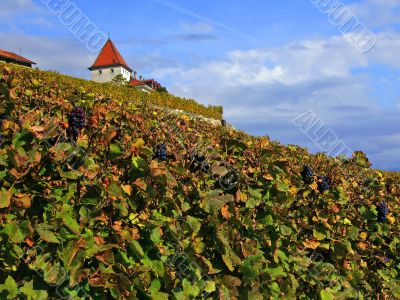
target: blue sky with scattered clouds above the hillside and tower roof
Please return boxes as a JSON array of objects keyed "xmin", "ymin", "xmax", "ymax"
[{"xmin": 0, "ymin": 0, "xmax": 400, "ymax": 170}]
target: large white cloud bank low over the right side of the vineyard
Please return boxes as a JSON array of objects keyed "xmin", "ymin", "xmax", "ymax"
[{"xmin": 152, "ymin": 33, "xmax": 400, "ymax": 169}]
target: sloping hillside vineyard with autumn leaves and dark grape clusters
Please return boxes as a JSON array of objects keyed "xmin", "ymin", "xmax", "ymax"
[{"xmin": 0, "ymin": 65, "xmax": 400, "ymax": 300}]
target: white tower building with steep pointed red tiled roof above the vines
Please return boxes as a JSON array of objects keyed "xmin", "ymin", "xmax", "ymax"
[{"xmin": 89, "ymin": 39, "xmax": 161, "ymax": 92}]
